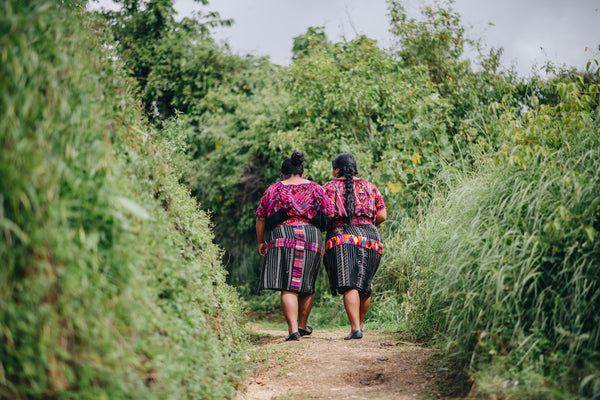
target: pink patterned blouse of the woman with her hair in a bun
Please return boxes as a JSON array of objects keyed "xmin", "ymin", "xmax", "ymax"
[{"xmin": 256, "ymin": 182, "xmax": 335, "ymax": 219}]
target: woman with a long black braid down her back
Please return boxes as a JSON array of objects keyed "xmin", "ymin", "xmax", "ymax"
[{"xmin": 323, "ymin": 153, "xmax": 387, "ymax": 340}]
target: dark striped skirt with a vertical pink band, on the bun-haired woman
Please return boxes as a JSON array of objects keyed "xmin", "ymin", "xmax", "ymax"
[{"xmin": 256, "ymin": 224, "xmax": 324, "ymax": 294}]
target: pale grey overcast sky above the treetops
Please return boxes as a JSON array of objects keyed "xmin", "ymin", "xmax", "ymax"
[{"xmin": 94, "ymin": 0, "xmax": 600, "ymax": 75}]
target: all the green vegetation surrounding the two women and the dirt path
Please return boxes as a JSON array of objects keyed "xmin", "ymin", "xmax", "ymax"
[{"xmin": 0, "ymin": 0, "xmax": 600, "ymax": 399}]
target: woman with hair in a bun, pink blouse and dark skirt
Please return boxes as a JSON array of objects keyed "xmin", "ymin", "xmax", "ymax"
[{"xmin": 256, "ymin": 152, "xmax": 334, "ymax": 340}]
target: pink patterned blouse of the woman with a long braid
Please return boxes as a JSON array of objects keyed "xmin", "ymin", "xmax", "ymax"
[{"xmin": 323, "ymin": 179, "xmax": 385, "ymax": 226}]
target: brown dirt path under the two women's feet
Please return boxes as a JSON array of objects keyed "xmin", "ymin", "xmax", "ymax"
[{"xmin": 236, "ymin": 326, "xmax": 433, "ymax": 400}]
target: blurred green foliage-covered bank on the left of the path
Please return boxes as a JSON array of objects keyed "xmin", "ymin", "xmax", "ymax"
[{"xmin": 0, "ymin": 0, "xmax": 243, "ymax": 399}]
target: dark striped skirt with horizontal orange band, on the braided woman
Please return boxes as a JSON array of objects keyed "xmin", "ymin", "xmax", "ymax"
[{"xmin": 323, "ymin": 224, "xmax": 383, "ymax": 296}]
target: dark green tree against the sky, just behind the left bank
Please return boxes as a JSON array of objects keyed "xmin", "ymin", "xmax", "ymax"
[{"xmin": 97, "ymin": 0, "xmax": 240, "ymax": 121}]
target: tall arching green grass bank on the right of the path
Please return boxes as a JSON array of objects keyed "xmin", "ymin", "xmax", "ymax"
[{"xmin": 380, "ymin": 76, "xmax": 600, "ymax": 398}]
